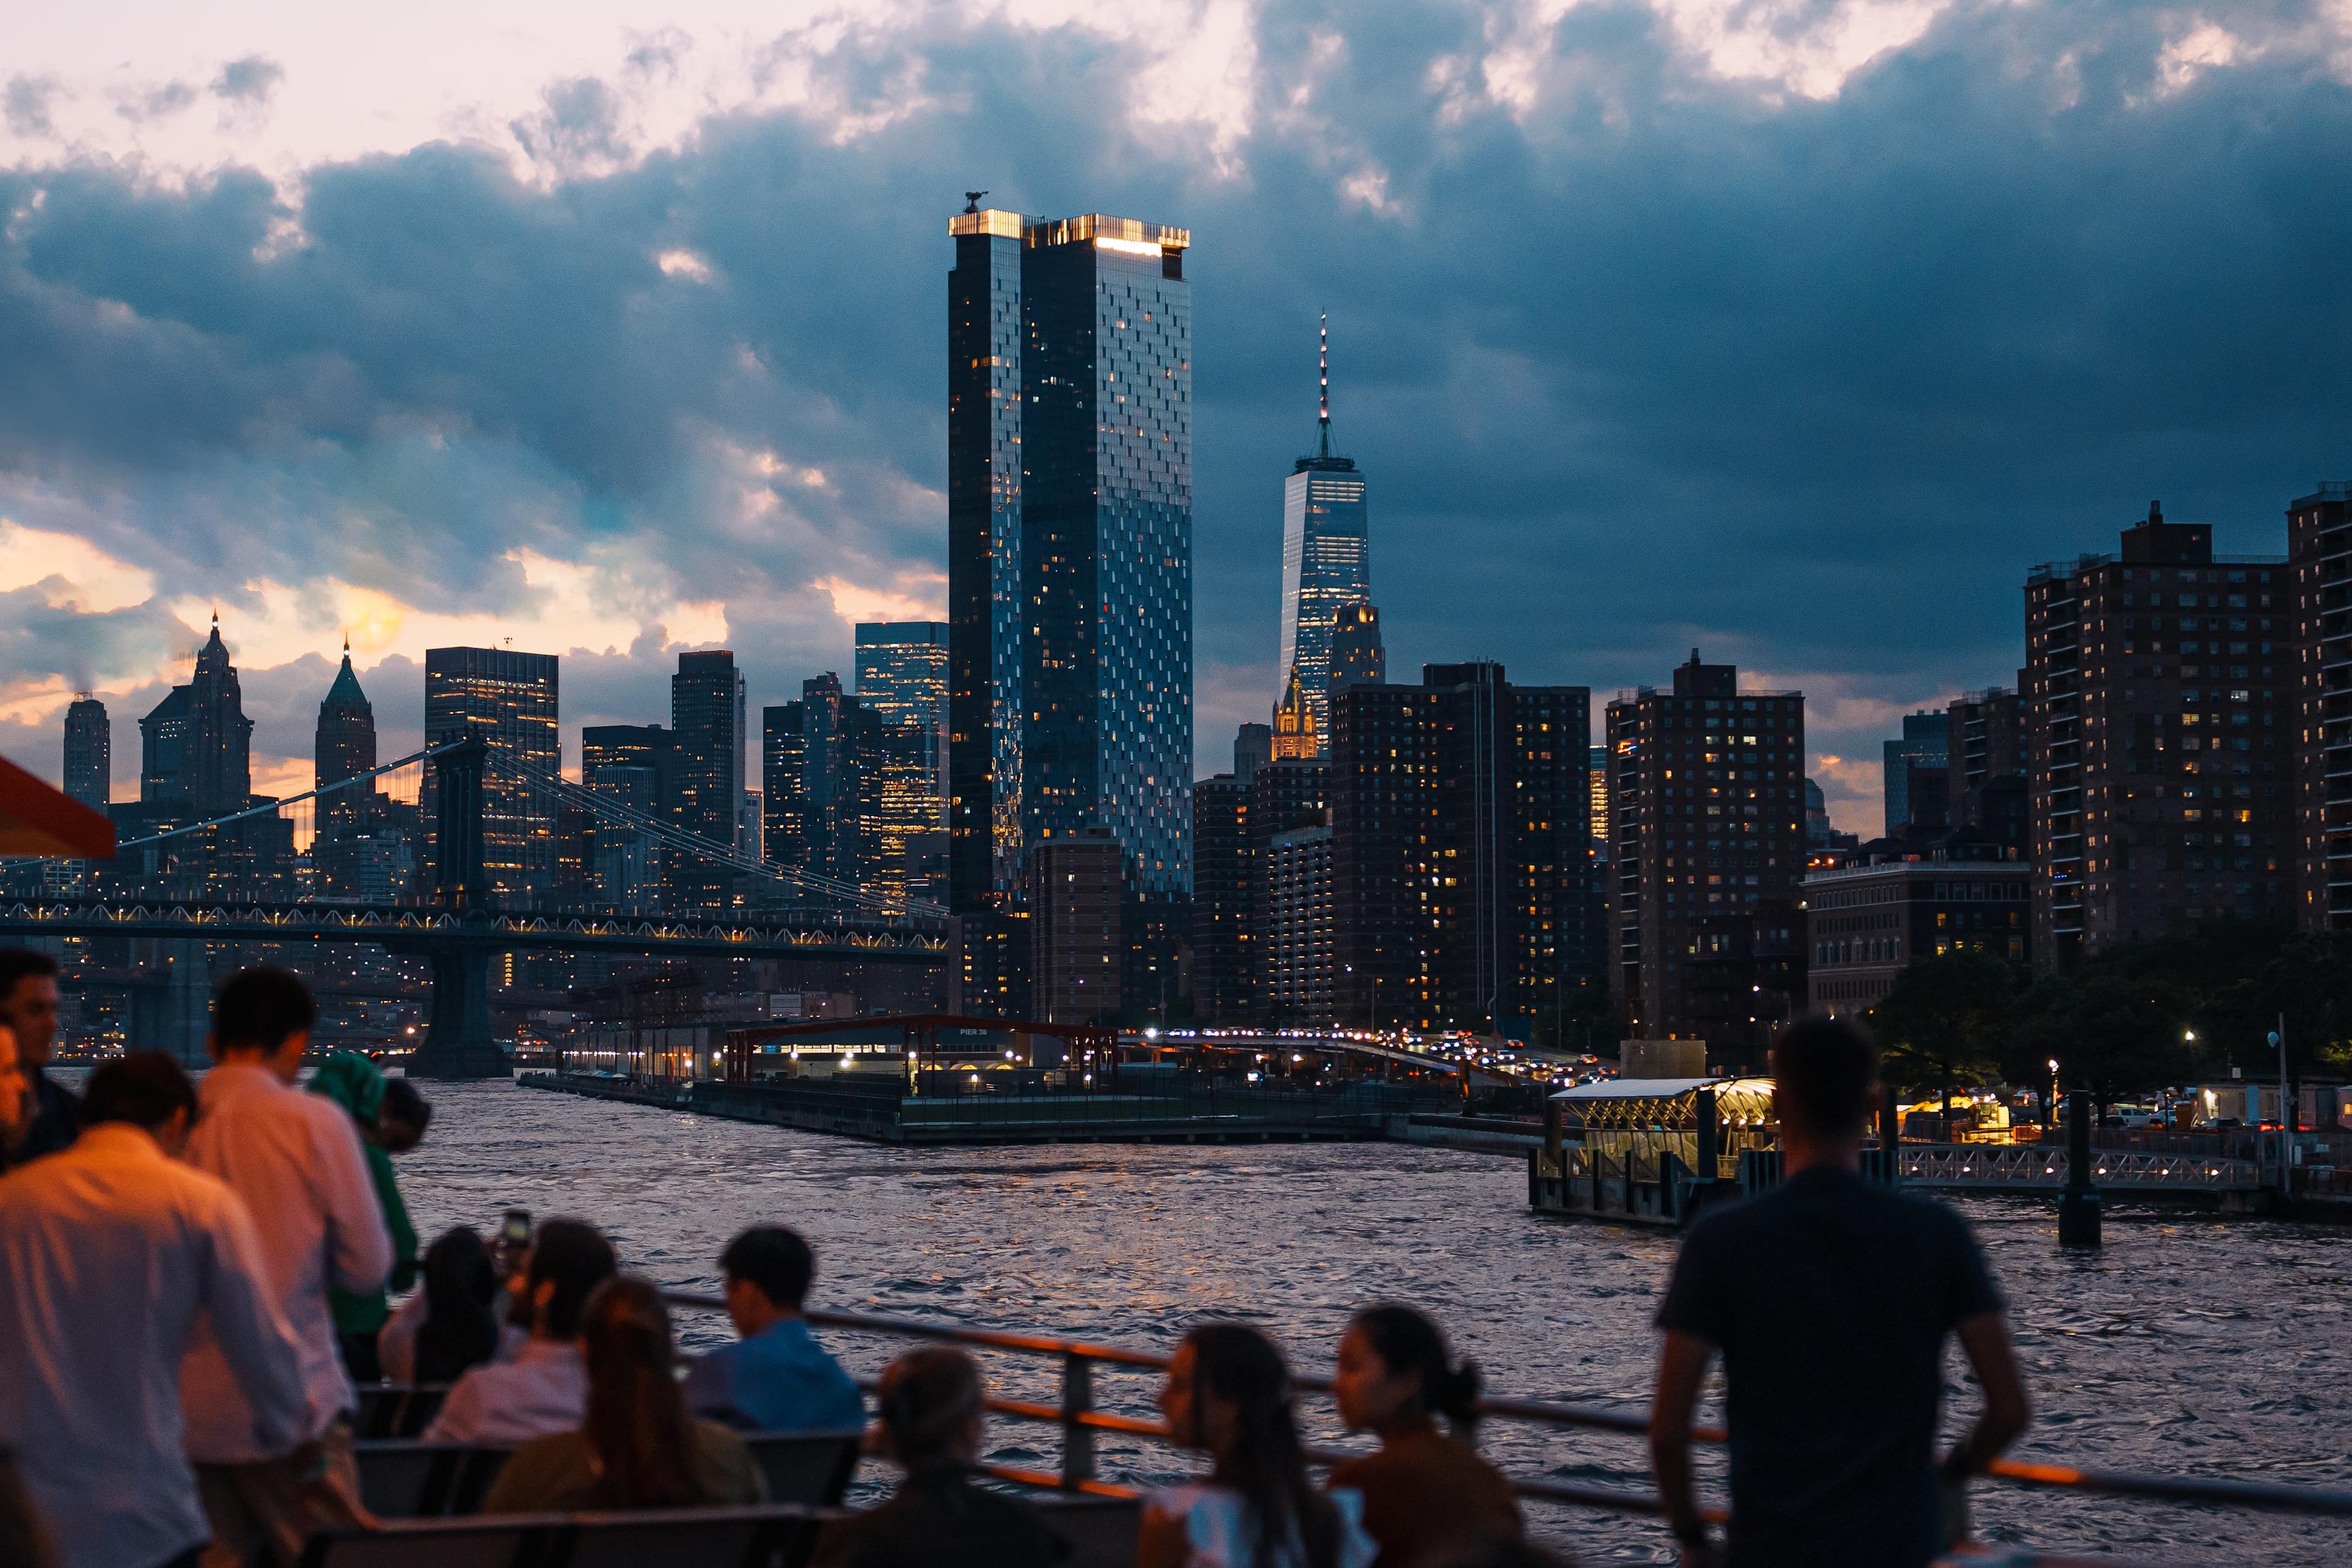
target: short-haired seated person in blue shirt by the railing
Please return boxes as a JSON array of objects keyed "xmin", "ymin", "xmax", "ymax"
[{"xmin": 687, "ymin": 1225, "xmax": 865, "ymax": 1431}]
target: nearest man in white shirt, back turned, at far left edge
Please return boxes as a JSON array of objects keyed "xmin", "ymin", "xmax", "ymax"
[{"xmin": 0, "ymin": 1051, "xmax": 308, "ymax": 1568}]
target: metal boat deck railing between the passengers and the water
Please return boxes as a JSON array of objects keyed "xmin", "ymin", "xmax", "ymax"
[{"xmin": 668, "ymin": 1291, "xmax": 2352, "ymax": 1568}]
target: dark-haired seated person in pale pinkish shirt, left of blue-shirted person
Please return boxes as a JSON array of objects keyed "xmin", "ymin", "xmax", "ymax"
[{"xmin": 423, "ymin": 1220, "xmax": 619, "ymax": 1448}]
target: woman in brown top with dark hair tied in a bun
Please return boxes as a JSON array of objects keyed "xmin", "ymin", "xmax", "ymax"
[{"xmin": 1331, "ymin": 1305, "xmax": 1521, "ymax": 1568}]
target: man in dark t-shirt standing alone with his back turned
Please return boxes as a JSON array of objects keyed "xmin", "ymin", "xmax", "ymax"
[{"xmin": 1651, "ymin": 1016, "xmax": 2027, "ymax": 1568}]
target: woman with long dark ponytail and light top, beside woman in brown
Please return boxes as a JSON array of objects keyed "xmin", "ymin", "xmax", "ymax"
[{"xmin": 1136, "ymin": 1324, "xmax": 1374, "ymax": 1568}]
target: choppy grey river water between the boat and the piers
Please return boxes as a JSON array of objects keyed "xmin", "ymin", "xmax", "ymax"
[{"xmin": 400, "ymin": 1084, "xmax": 2352, "ymax": 1568}]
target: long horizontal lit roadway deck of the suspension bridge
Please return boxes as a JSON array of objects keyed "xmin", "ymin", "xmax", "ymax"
[{"xmin": 0, "ymin": 898, "xmax": 948, "ymax": 964}]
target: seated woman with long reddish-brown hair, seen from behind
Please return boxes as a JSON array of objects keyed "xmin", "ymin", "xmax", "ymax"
[{"xmin": 482, "ymin": 1274, "xmax": 767, "ymax": 1514}]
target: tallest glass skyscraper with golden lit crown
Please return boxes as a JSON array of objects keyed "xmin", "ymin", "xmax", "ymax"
[{"xmin": 948, "ymin": 207, "xmax": 1193, "ymax": 912}]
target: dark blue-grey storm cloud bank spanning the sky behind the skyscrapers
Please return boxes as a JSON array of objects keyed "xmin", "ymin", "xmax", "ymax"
[{"xmin": 0, "ymin": 5, "xmax": 2352, "ymax": 827}]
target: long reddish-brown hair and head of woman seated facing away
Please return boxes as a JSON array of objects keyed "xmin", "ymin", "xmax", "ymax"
[{"xmin": 576, "ymin": 1278, "xmax": 703, "ymax": 1509}]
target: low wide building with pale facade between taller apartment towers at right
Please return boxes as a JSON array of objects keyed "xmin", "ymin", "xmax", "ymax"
[{"xmin": 1804, "ymin": 835, "xmax": 2032, "ymax": 1013}]
